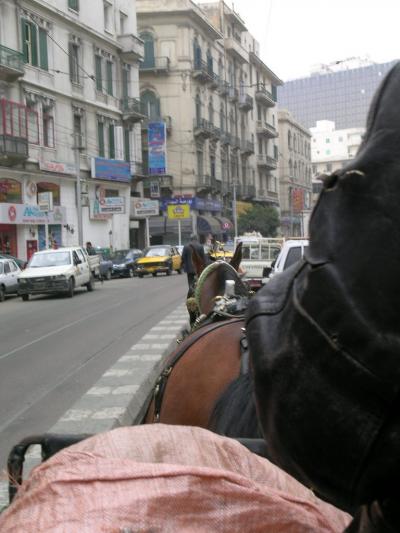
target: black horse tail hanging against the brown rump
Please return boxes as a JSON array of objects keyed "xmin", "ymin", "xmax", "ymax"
[{"xmin": 208, "ymin": 373, "xmax": 262, "ymax": 438}]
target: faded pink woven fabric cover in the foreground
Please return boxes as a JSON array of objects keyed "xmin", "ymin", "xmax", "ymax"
[{"xmin": 0, "ymin": 424, "xmax": 350, "ymax": 533}]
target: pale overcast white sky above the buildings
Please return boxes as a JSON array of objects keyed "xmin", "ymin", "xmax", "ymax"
[{"xmin": 197, "ymin": 0, "xmax": 400, "ymax": 81}]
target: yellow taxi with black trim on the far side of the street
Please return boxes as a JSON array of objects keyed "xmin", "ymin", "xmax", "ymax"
[{"xmin": 135, "ymin": 244, "xmax": 182, "ymax": 278}]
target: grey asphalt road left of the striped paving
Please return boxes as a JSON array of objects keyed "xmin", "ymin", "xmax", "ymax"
[{"xmin": 0, "ymin": 273, "xmax": 187, "ymax": 470}]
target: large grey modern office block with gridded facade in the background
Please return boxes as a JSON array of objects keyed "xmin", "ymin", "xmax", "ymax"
[{"xmin": 278, "ymin": 61, "xmax": 397, "ymax": 129}]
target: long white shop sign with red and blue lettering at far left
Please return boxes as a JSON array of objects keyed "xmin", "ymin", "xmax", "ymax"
[{"xmin": 0, "ymin": 204, "xmax": 66, "ymax": 224}]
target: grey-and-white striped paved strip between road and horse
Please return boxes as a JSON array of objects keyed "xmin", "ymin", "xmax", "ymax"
[{"xmin": 0, "ymin": 304, "xmax": 188, "ymax": 509}]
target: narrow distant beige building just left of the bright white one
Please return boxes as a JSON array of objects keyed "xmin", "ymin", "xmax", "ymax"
[{"xmin": 278, "ymin": 109, "xmax": 312, "ymax": 237}]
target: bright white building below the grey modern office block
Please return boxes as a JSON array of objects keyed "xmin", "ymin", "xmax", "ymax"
[{"xmin": 310, "ymin": 120, "xmax": 365, "ymax": 206}]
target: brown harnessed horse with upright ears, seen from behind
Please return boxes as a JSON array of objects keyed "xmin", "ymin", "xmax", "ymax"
[{"xmin": 144, "ymin": 245, "xmax": 252, "ymax": 428}]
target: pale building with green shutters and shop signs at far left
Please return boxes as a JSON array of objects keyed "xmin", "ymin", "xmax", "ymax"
[{"xmin": 0, "ymin": 0, "xmax": 143, "ymax": 259}]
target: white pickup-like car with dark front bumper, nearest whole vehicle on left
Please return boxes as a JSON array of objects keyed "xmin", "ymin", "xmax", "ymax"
[{"xmin": 18, "ymin": 246, "xmax": 94, "ymax": 301}]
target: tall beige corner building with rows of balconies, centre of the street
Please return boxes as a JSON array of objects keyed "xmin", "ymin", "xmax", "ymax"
[{"xmin": 136, "ymin": 0, "xmax": 281, "ymax": 243}]
